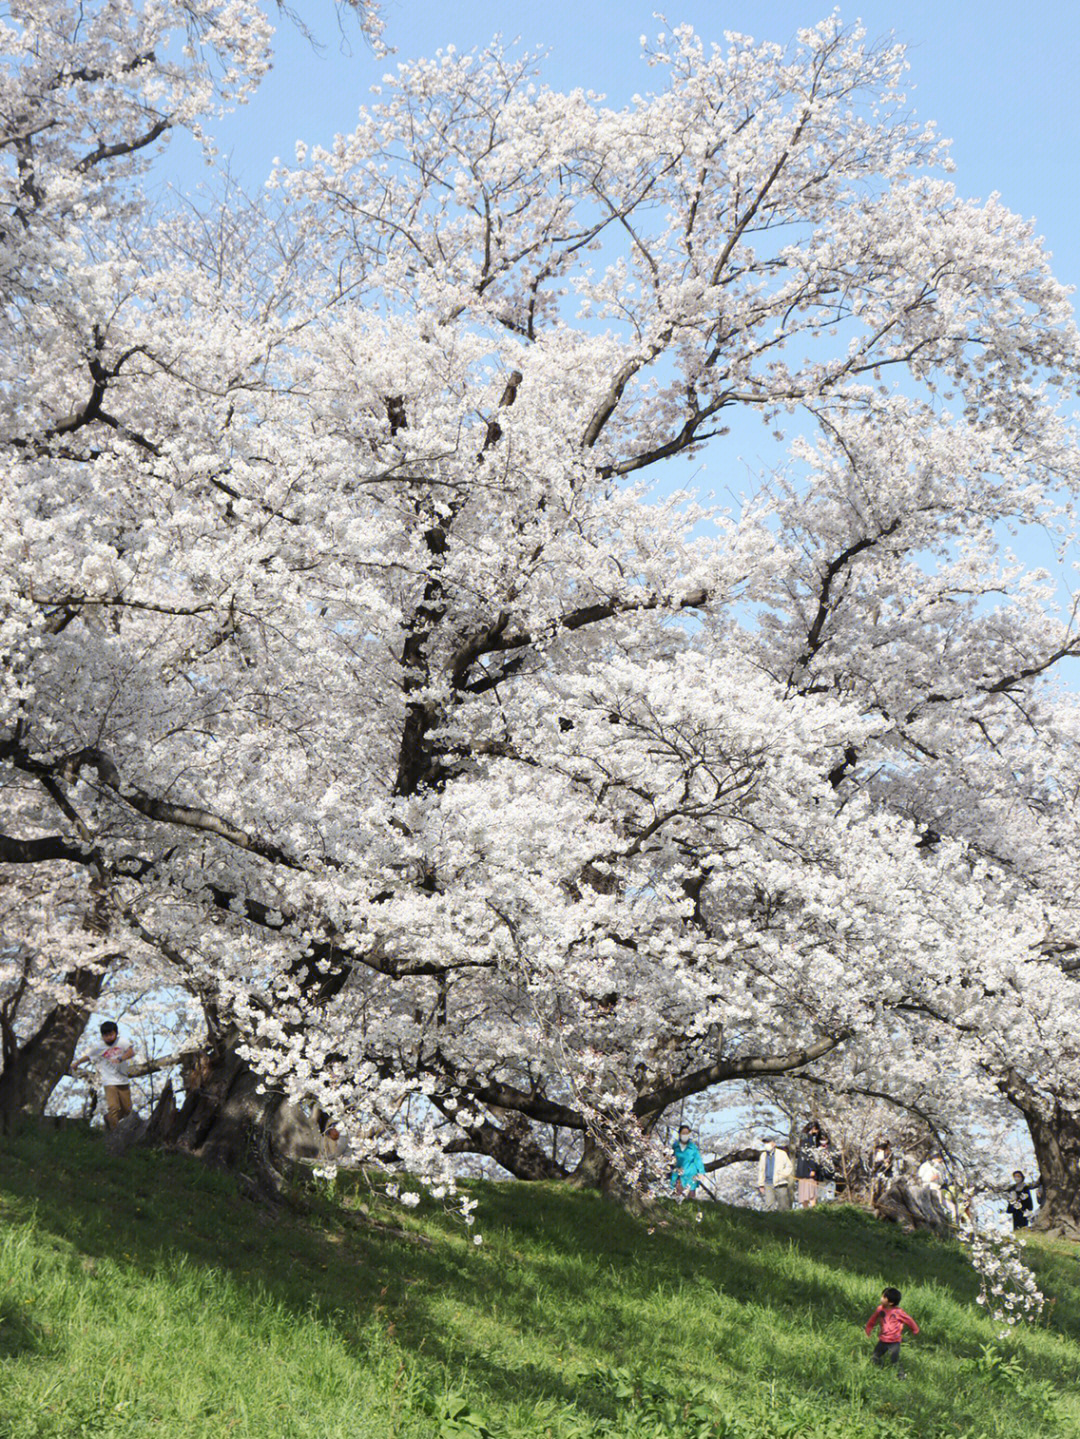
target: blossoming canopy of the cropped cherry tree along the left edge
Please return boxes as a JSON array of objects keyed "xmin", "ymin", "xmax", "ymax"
[{"xmin": 0, "ymin": 0, "xmax": 381, "ymax": 1124}]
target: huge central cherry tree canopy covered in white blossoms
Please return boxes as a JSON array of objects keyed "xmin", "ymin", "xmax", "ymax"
[{"xmin": 0, "ymin": 19, "xmax": 1080, "ymax": 1203}]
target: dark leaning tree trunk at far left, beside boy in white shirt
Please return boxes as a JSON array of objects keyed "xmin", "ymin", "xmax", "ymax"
[{"xmin": 0, "ymin": 970, "xmax": 105, "ymax": 1134}]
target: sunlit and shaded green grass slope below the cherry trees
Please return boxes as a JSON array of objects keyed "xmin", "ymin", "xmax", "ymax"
[{"xmin": 0, "ymin": 1130, "xmax": 1080, "ymax": 1439}]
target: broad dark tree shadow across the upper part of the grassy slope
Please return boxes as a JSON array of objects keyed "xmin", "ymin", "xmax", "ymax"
[{"xmin": 0, "ymin": 1130, "xmax": 1076, "ymax": 1423}]
